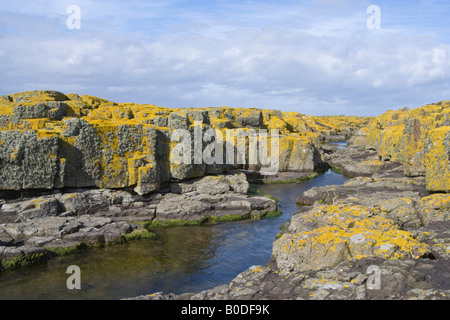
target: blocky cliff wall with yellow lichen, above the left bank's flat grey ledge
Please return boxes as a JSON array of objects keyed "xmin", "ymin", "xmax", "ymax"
[{"xmin": 0, "ymin": 91, "xmax": 368, "ymax": 195}]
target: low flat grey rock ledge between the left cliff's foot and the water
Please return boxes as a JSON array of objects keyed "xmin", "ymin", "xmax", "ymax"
[{"xmin": 0, "ymin": 173, "xmax": 280, "ymax": 269}]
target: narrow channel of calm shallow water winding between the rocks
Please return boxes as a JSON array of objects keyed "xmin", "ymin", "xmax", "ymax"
[{"xmin": 0, "ymin": 171, "xmax": 346, "ymax": 300}]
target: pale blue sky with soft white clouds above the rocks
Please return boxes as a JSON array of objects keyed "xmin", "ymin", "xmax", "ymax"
[{"xmin": 0, "ymin": 0, "xmax": 450, "ymax": 116}]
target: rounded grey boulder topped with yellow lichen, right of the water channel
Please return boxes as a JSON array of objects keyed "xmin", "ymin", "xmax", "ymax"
[{"xmin": 273, "ymin": 205, "xmax": 430, "ymax": 271}]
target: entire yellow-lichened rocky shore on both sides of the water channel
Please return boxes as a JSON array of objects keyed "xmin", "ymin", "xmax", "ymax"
[{"xmin": 0, "ymin": 91, "xmax": 450, "ymax": 299}]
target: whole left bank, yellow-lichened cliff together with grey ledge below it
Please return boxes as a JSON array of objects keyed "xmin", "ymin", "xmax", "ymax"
[{"xmin": 0, "ymin": 90, "xmax": 369, "ymax": 271}]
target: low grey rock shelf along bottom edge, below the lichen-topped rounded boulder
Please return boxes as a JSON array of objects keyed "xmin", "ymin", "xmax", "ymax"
[{"xmin": 130, "ymin": 258, "xmax": 450, "ymax": 300}]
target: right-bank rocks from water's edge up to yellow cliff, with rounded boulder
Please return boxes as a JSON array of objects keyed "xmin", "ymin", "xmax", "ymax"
[{"xmin": 130, "ymin": 146, "xmax": 450, "ymax": 300}]
